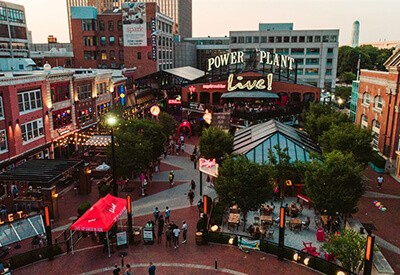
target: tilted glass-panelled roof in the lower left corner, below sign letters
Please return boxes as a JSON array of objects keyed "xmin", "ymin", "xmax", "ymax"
[{"xmin": 0, "ymin": 215, "xmax": 45, "ymax": 247}]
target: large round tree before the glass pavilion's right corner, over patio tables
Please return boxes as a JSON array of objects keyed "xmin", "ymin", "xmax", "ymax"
[{"xmin": 305, "ymin": 150, "xmax": 365, "ymax": 223}]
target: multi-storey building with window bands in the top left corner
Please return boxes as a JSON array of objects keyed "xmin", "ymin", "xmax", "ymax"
[{"xmin": 0, "ymin": 1, "xmax": 29, "ymax": 58}]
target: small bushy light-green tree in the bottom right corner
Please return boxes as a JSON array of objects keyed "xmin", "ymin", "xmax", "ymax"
[{"xmin": 323, "ymin": 229, "xmax": 367, "ymax": 274}]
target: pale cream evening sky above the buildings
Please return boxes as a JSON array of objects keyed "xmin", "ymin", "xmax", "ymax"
[{"xmin": 6, "ymin": 0, "xmax": 400, "ymax": 45}]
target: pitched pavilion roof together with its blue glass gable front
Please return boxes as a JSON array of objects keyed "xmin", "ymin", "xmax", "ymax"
[{"xmin": 232, "ymin": 119, "xmax": 321, "ymax": 163}]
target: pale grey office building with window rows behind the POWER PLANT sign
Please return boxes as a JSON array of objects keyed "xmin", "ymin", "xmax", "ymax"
[{"xmin": 229, "ymin": 23, "xmax": 339, "ymax": 90}]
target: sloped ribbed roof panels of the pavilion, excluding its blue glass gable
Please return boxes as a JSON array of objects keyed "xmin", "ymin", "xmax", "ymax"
[{"xmin": 233, "ymin": 119, "xmax": 321, "ymax": 162}]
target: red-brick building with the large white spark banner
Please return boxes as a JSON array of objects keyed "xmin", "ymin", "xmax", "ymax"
[{"xmin": 71, "ymin": 2, "xmax": 174, "ymax": 77}]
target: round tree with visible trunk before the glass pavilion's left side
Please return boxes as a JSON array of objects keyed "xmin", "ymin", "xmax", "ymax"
[{"xmin": 214, "ymin": 155, "xmax": 272, "ymax": 232}]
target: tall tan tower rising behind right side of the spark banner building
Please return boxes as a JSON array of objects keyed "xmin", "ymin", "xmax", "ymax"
[{"xmin": 138, "ymin": 0, "xmax": 193, "ymax": 38}]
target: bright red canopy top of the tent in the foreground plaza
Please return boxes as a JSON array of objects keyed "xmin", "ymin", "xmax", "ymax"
[{"xmin": 71, "ymin": 194, "xmax": 126, "ymax": 232}]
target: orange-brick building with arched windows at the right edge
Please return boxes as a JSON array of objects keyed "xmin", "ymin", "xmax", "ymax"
[{"xmin": 355, "ymin": 49, "xmax": 400, "ymax": 169}]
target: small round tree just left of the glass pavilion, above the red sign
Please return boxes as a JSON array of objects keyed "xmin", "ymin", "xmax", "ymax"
[{"xmin": 199, "ymin": 127, "xmax": 233, "ymax": 162}]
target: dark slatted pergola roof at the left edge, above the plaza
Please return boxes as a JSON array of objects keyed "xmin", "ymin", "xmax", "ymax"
[{"xmin": 0, "ymin": 159, "xmax": 83, "ymax": 184}]
